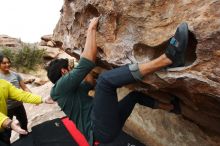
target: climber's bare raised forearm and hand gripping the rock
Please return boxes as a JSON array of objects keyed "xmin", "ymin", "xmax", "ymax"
[{"xmin": 81, "ymin": 17, "xmax": 99, "ymax": 62}]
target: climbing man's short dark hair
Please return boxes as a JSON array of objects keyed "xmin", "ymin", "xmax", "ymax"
[{"xmin": 46, "ymin": 59, "xmax": 68, "ymax": 84}]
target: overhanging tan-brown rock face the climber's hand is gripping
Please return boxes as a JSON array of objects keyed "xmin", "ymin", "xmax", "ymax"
[{"xmin": 53, "ymin": 0, "xmax": 220, "ymax": 144}]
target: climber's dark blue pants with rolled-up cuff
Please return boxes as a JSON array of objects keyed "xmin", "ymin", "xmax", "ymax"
[{"xmin": 92, "ymin": 66, "xmax": 156, "ymax": 143}]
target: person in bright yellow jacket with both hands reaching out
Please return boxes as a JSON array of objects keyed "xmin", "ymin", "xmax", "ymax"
[{"xmin": 0, "ymin": 79, "xmax": 54, "ymax": 145}]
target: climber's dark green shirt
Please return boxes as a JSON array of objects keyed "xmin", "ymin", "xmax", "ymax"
[{"xmin": 51, "ymin": 58, "xmax": 95, "ymax": 145}]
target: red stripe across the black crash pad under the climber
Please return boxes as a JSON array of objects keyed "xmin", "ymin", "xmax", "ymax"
[{"xmin": 62, "ymin": 117, "xmax": 89, "ymax": 146}]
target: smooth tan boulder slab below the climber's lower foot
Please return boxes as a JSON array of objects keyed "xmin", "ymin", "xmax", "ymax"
[{"xmin": 124, "ymin": 105, "xmax": 215, "ymax": 146}]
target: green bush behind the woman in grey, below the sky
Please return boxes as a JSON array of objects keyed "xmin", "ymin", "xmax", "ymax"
[{"xmin": 2, "ymin": 44, "xmax": 45, "ymax": 72}]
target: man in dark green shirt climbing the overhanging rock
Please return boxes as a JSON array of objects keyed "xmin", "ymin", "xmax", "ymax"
[{"xmin": 47, "ymin": 18, "xmax": 188, "ymax": 145}]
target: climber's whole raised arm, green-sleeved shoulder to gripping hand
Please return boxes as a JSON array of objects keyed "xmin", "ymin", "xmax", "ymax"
[{"xmin": 55, "ymin": 18, "xmax": 98, "ymax": 93}]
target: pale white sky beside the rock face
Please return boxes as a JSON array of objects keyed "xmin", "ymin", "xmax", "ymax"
[{"xmin": 0, "ymin": 0, "xmax": 63, "ymax": 43}]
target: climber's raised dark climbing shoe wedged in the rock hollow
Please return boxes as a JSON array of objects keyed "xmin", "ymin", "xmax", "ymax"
[{"xmin": 165, "ymin": 23, "xmax": 188, "ymax": 68}]
